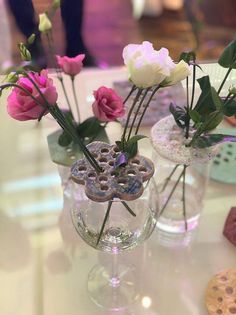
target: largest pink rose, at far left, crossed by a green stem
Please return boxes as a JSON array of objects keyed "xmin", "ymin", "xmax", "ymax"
[{"xmin": 7, "ymin": 70, "xmax": 57, "ymax": 121}]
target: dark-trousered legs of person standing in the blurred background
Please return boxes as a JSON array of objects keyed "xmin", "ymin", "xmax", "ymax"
[{"xmin": 6, "ymin": 0, "xmax": 96, "ymax": 68}]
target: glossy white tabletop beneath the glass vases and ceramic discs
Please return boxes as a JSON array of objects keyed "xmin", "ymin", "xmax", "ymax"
[{"xmin": 0, "ymin": 65, "xmax": 236, "ymax": 315}]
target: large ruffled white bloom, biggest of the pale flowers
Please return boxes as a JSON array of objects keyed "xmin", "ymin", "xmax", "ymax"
[{"xmin": 123, "ymin": 42, "xmax": 175, "ymax": 88}]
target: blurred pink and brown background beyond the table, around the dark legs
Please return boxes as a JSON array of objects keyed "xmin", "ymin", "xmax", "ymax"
[{"xmin": 0, "ymin": 0, "xmax": 236, "ymax": 68}]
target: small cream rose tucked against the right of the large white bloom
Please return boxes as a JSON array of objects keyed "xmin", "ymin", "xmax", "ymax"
[{"xmin": 162, "ymin": 60, "xmax": 191, "ymax": 86}]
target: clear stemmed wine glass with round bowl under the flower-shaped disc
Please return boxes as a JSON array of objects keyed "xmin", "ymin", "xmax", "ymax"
[{"xmin": 71, "ymin": 178, "xmax": 159, "ymax": 310}]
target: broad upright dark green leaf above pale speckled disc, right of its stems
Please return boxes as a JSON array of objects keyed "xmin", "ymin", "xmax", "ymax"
[{"xmin": 194, "ymin": 76, "xmax": 216, "ymax": 118}]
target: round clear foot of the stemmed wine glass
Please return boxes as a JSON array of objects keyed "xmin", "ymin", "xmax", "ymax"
[{"xmin": 88, "ymin": 265, "xmax": 139, "ymax": 311}]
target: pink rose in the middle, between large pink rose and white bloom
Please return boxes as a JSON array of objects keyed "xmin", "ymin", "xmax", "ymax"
[{"xmin": 92, "ymin": 86, "xmax": 125, "ymax": 121}]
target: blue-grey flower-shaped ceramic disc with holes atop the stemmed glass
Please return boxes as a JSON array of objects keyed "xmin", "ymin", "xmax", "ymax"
[{"xmin": 71, "ymin": 141, "xmax": 154, "ymax": 202}]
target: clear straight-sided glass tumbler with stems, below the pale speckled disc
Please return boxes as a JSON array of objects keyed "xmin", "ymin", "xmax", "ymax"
[{"xmin": 153, "ymin": 151, "xmax": 209, "ymax": 234}]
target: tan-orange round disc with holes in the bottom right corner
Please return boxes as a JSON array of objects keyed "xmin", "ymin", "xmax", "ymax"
[{"xmin": 206, "ymin": 269, "xmax": 236, "ymax": 315}]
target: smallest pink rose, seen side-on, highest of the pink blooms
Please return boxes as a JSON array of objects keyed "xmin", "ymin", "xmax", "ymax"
[{"xmin": 56, "ymin": 54, "xmax": 85, "ymax": 77}]
